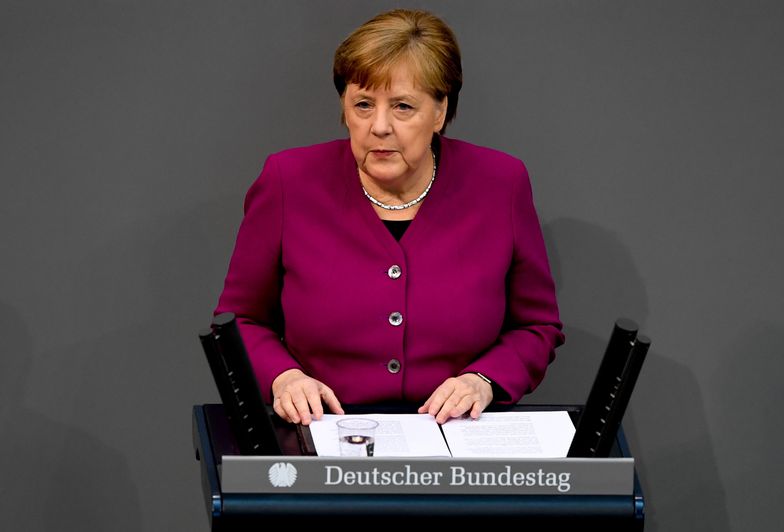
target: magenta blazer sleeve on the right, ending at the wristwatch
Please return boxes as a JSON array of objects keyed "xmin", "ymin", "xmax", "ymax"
[{"xmin": 465, "ymin": 162, "xmax": 564, "ymax": 404}]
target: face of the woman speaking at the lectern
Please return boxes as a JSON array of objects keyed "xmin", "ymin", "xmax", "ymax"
[{"xmin": 342, "ymin": 65, "xmax": 447, "ymax": 188}]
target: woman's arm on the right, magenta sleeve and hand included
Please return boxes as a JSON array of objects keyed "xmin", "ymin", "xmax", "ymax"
[{"xmin": 419, "ymin": 160, "xmax": 563, "ymax": 423}]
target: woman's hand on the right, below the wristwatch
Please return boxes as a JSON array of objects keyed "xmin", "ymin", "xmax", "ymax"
[{"xmin": 418, "ymin": 373, "xmax": 493, "ymax": 423}]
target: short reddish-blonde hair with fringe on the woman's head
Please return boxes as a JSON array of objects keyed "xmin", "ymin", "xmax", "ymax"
[{"xmin": 332, "ymin": 9, "xmax": 463, "ymax": 133}]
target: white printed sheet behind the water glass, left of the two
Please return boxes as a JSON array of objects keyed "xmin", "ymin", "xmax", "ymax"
[{"xmin": 310, "ymin": 414, "xmax": 450, "ymax": 457}]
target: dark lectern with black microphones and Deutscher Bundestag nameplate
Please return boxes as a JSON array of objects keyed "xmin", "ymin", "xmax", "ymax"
[{"xmin": 198, "ymin": 313, "xmax": 650, "ymax": 532}]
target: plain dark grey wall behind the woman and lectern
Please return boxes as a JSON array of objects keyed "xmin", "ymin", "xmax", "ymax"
[{"xmin": 0, "ymin": 0, "xmax": 784, "ymax": 532}]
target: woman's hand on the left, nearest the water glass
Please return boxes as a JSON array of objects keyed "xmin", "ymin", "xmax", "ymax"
[{"xmin": 272, "ymin": 369, "xmax": 343, "ymax": 425}]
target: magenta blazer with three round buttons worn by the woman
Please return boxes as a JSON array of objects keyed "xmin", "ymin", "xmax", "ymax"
[{"xmin": 215, "ymin": 138, "xmax": 564, "ymax": 404}]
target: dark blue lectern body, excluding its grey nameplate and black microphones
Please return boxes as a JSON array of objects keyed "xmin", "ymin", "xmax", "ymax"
[{"xmin": 193, "ymin": 404, "xmax": 644, "ymax": 532}]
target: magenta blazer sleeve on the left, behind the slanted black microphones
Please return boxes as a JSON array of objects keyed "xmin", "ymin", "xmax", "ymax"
[{"xmin": 214, "ymin": 156, "xmax": 301, "ymax": 403}]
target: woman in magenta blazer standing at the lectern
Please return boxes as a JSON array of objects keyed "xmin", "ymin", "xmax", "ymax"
[{"xmin": 215, "ymin": 10, "xmax": 563, "ymax": 425}]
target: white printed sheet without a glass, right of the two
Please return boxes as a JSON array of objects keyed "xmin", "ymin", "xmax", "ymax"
[{"xmin": 441, "ymin": 410, "xmax": 575, "ymax": 458}]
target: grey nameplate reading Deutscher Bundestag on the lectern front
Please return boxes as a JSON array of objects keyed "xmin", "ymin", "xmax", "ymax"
[{"xmin": 220, "ymin": 455, "xmax": 634, "ymax": 495}]
